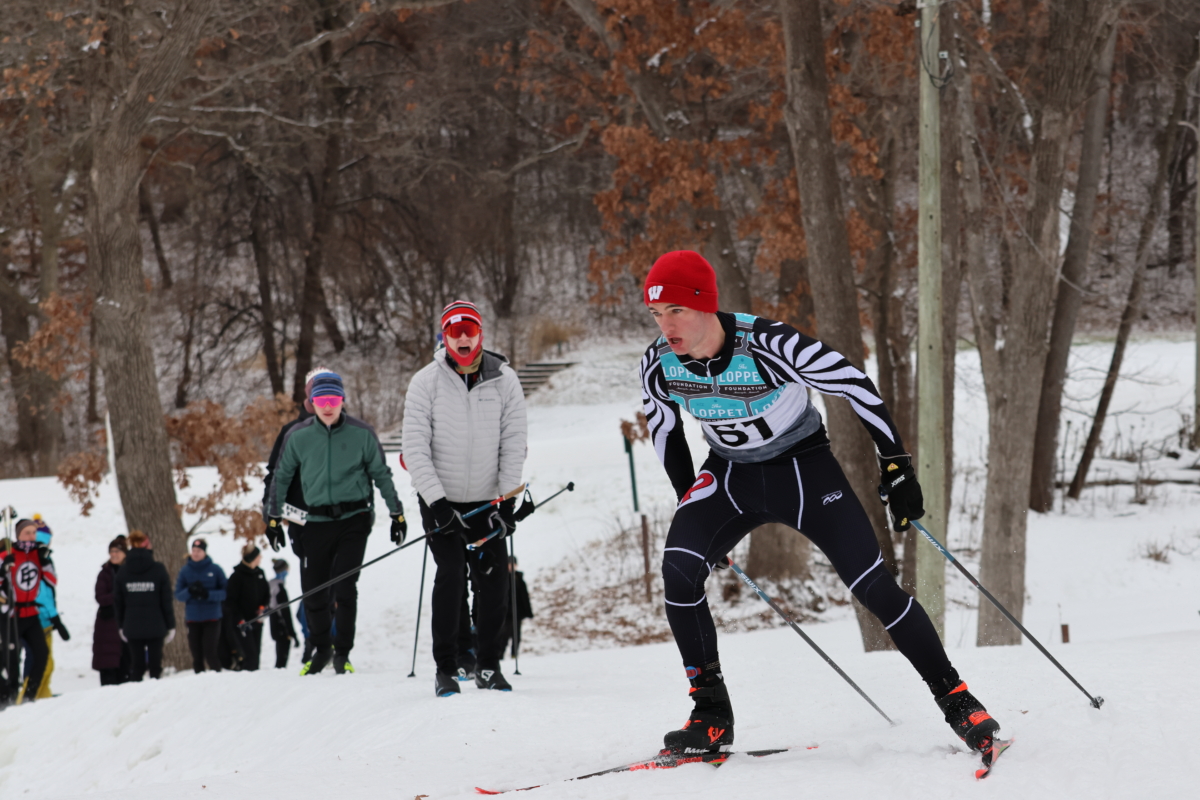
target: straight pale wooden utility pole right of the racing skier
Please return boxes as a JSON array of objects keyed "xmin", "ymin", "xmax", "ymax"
[{"xmin": 905, "ymin": 0, "xmax": 947, "ymax": 640}]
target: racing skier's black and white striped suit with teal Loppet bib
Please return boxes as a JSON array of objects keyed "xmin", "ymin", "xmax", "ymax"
[{"xmin": 641, "ymin": 312, "xmax": 950, "ymax": 680}]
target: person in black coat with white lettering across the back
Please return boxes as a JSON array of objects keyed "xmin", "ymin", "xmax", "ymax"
[{"xmin": 113, "ymin": 530, "xmax": 175, "ymax": 681}]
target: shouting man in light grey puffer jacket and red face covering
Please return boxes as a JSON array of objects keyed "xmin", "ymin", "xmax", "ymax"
[{"xmin": 403, "ymin": 300, "xmax": 533, "ymax": 697}]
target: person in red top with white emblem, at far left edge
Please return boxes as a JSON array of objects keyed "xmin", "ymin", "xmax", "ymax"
[{"xmin": 0, "ymin": 519, "xmax": 58, "ymax": 703}]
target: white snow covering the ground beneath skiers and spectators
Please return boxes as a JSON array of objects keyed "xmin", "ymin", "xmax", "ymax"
[{"xmin": 0, "ymin": 339, "xmax": 1200, "ymax": 800}]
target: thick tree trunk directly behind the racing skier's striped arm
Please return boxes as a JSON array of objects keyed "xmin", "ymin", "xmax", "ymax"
[{"xmin": 779, "ymin": 0, "xmax": 895, "ymax": 650}]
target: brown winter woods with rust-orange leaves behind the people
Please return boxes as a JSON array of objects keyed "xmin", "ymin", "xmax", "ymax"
[{"xmin": 0, "ymin": 0, "xmax": 1200, "ymax": 662}]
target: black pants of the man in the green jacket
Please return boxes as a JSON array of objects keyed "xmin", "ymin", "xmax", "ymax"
[{"xmin": 293, "ymin": 511, "xmax": 372, "ymax": 654}]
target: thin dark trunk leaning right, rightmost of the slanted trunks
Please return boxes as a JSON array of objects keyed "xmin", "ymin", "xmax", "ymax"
[{"xmin": 1068, "ymin": 70, "xmax": 1188, "ymax": 500}]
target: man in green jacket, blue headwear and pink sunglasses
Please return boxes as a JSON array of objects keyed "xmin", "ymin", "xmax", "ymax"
[{"xmin": 268, "ymin": 372, "xmax": 408, "ymax": 675}]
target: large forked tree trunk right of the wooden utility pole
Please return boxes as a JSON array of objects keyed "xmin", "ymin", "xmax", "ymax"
[{"xmin": 955, "ymin": 0, "xmax": 1116, "ymax": 645}]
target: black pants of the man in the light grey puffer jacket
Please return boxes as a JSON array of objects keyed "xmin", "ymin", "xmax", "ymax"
[{"xmin": 420, "ymin": 500, "xmax": 509, "ymax": 674}]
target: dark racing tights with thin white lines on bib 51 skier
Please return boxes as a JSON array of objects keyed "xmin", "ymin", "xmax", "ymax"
[{"xmin": 662, "ymin": 445, "xmax": 950, "ymax": 680}]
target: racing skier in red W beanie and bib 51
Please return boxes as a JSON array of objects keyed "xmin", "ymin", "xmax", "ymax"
[{"xmin": 641, "ymin": 251, "xmax": 1000, "ymax": 752}]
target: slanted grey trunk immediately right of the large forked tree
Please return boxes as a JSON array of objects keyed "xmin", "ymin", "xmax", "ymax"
[{"xmin": 1030, "ymin": 26, "xmax": 1117, "ymax": 512}]
